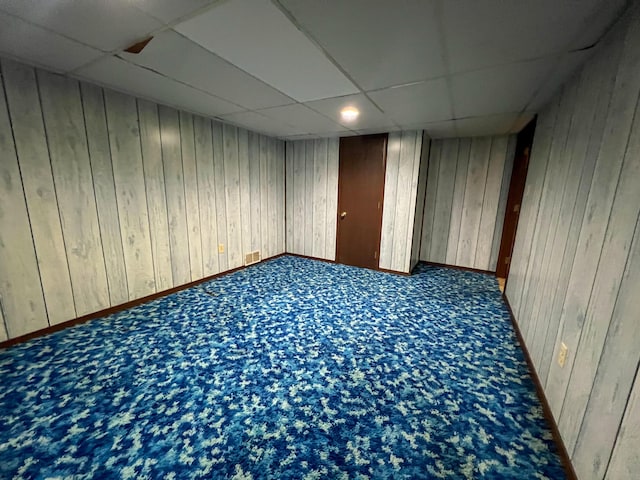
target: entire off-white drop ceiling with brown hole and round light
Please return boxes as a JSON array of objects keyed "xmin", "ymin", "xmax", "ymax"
[{"xmin": 0, "ymin": 0, "xmax": 627, "ymax": 139}]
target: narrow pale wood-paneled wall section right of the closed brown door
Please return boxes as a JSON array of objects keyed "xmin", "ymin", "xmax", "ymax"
[{"xmin": 380, "ymin": 130, "xmax": 428, "ymax": 273}]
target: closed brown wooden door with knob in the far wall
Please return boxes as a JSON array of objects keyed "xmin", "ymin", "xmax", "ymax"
[{"xmin": 336, "ymin": 134, "xmax": 387, "ymax": 269}]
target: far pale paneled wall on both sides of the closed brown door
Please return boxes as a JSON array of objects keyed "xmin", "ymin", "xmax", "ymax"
[{"xmin": 286, "ymin": 131, "xmax": 422, "ymax": 272}]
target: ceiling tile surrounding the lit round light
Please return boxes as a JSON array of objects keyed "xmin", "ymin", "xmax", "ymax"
[{"xmin": 305, "ymin": 94, "xmax": 395, "ymax": 130}]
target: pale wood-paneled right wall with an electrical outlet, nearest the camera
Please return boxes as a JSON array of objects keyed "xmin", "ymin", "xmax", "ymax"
[{"xmin": 506, "ymin": 2, "xmax": 640, "ymax": 480}]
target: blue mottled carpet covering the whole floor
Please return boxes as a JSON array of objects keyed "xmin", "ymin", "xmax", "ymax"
[{"xmin": 0, "ymin": 257, "xmax": 564, "ymax": 480}]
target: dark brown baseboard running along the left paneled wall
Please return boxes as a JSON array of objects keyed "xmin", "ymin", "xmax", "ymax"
[{"xmin": 0, "ymin": 253, "xmax": 288, "ymax": 348}]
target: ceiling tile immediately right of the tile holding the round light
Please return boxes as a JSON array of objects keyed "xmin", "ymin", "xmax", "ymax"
[{"xmin": 368, "ymin": 78, "xmax": 453, "ymax": 125}]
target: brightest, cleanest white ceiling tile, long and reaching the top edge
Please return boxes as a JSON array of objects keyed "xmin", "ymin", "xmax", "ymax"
[{"xmin": 175, "ymin": 0, "xmax": 358, "ymax": 102}]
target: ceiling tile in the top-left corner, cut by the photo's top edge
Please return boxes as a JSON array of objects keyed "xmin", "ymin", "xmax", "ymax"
[{"xmin": 0, "ymin": 0, "xmax": 161, "ymax": 51}]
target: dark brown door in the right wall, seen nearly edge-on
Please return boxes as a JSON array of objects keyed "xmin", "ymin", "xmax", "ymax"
[{"xmin": 496, "ymin": 118, "xmax": 536, "ymax": 278}]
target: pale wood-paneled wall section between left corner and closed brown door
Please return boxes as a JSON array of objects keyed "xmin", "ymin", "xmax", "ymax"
[{"xmin": 286, "ymin": 138, "xmax": 340, "ymax": 260}]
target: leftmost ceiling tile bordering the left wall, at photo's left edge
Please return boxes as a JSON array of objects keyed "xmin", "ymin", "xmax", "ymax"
[{"xmin": 0, "ymin": 12, "xmax": 102, "ymax": 72}]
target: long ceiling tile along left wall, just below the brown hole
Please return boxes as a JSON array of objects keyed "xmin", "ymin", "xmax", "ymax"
[{"xmin": 74, "ymin": 56, "xmax": 242, "ymax": 117}]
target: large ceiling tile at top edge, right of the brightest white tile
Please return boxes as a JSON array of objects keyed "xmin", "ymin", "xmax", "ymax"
[{"xmin": 280, "ymin": 0, "xmax": 448, "ymax": 90}]
